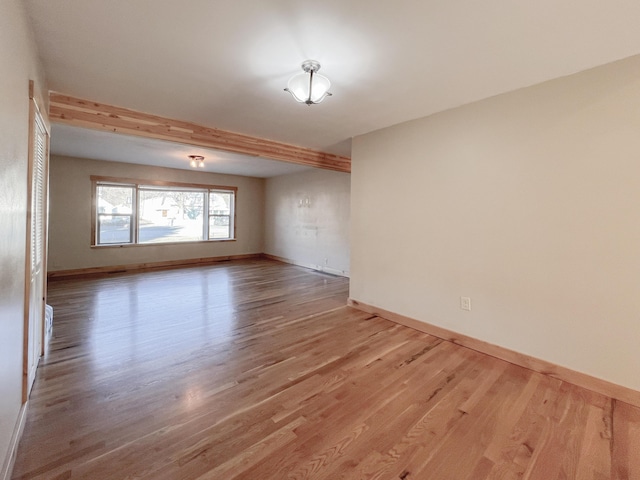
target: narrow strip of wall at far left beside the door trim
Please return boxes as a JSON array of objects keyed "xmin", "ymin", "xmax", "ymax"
[{"xmin": 0, "ymin": 0, "xmax": 46, "ymax": 478}]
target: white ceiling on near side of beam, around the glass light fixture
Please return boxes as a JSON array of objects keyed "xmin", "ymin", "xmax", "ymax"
[{"xmin": 25, "ymin": 0, "xmax": 640, "ymax": 176}]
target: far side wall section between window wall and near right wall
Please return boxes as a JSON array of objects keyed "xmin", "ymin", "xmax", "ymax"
[{"xmin": 264, "ymin": 169, "xmax": 351, "ymax": 276}]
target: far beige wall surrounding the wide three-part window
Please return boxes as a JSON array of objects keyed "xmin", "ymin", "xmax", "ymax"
[{"xmin": 48, "ymin": 155, "xmax": 264, "ymax": 272}]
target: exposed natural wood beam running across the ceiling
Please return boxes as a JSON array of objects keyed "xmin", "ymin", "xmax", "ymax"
[{"xmin": 49, "ymin": 92, "xmax": 351, "ymax": 172}]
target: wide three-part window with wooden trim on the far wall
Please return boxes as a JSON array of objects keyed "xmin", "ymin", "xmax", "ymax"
[{"xmin": 91, "ymin": 177, "xmax": 236, "ymax": 245}]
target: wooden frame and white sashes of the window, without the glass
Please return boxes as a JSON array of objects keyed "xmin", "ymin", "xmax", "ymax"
[{"xmin": 90, "ymin": 175, "xmax": 238, "ymax": 248}]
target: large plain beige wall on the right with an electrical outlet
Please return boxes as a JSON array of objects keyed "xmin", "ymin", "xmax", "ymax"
[{"xmin": 351, "ymin": 57, "xmax": 640, "ymax": 390}]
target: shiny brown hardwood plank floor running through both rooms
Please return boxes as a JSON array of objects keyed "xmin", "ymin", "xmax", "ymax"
[{"xmin": 13, "ymin": 260, "xmax": 640, "ymax": 480}]
